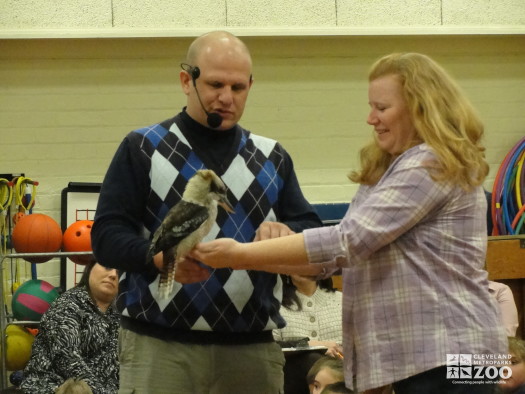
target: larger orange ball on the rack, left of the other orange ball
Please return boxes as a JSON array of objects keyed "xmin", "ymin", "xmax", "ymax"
[{"xmin": 12, "ymin": 213, "xmax": 62, "ymax": 263}]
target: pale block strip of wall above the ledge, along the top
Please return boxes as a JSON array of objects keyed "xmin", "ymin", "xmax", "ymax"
[{"xmin": 0, "ymin": 0, "xmax": 525, "ymax": 30}]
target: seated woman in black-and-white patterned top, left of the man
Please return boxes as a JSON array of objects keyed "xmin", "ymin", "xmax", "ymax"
[{"xmin": 20, "ymin": 262, "xmax": 119, "ymax": 394}]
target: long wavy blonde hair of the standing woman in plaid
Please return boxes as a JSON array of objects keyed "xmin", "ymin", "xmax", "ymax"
[{"xmin": 349, "ymin": 53, "xmax": 489, "ymax": 190}]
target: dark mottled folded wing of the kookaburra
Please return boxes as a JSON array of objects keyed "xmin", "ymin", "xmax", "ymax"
[{"xmin": 151, "ymin": 200, "xmax": 209, "ymax": 257}]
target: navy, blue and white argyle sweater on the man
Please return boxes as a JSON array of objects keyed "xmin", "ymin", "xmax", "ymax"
[{"xmin": 92, "ymin": 112, "xmax": 321, "ymax": 337}]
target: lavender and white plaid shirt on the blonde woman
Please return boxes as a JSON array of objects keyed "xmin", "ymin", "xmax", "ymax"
[{"xmin": 304, "ymin": 144, "xmax": 507, "ymax": 391}]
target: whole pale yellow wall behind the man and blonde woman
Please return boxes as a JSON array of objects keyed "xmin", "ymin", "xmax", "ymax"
[{"xmin": 0, "ymin": 0, "xmax": 525, "ymax": 285}]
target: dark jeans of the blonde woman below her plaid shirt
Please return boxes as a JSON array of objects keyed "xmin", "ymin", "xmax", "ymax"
[{"xmin": 392, "ymin": 366, "xmax": 497, "ymax": 394}]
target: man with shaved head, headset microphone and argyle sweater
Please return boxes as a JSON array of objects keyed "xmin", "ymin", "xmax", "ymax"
[{"xmin": 91, "ymin": 31, "xmax": 321, "ymax": 394}]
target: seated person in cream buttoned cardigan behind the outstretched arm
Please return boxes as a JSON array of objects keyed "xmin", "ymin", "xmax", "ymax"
[{"xmin": 273, "ymin": 275, "xmax": 343, "ymax": 394}]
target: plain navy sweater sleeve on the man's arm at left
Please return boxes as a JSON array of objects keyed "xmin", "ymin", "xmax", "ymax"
[{"xmin": 91, "ymin": 133, "xmax": 155, "ymax": 272}]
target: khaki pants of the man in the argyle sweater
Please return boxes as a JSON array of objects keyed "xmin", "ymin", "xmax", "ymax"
[{"xmin": 119, "ymin": 329, "xmax": 284, "ymax": 394}]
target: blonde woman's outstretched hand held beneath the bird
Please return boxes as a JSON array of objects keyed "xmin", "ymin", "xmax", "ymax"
[{"xmin": 189, "ymin": 238, "xmax": 242, "ymax": 268}]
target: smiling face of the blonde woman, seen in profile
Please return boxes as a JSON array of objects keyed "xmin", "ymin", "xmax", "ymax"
[{"xmin": 366, "ymin": 75, "xmax": 416, "ymax": 156}]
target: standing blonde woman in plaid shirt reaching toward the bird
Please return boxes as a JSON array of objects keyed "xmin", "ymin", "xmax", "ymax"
[{"xmin": 193, "ymin": 53, "xmax": 507, "ymax": 394}]
